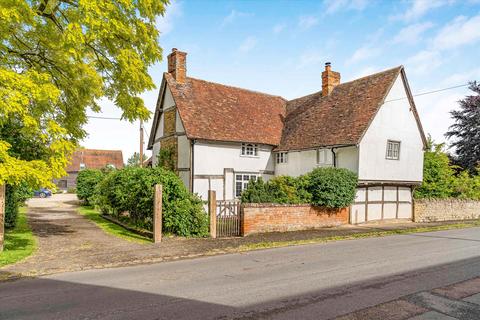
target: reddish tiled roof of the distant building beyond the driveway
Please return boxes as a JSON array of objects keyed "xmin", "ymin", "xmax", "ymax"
[{"xmin": 67, "ymin": 149, "xmax": 123, "ymax": 172}]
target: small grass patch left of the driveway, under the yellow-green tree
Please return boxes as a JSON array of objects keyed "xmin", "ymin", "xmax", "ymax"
[{"xmin": 0, "ymin": 207, "xmax": 37, "ymax": 267}]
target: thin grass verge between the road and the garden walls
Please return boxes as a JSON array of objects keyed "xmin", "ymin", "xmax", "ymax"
[{"xmin": 237, "ymin": 220, "xmax": 480, "ymax": 252}]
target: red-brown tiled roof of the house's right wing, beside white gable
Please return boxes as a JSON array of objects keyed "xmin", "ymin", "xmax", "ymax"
[{"xmin": 276, "ymin": 66, "xmax": 403, "ymax": 151}]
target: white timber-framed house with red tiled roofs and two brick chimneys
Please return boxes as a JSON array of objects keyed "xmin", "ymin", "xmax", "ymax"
[{"xmin": 148, "ymin": 49, "xmax": 426, "ymax": 223}]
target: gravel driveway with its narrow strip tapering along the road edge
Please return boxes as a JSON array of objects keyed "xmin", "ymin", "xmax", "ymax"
[{"xmin": 0, "ymin": 194, "xmax": 476, "ymax": 280}]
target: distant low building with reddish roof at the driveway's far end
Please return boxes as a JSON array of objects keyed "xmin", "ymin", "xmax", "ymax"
[{"xmin": 54, "ymin": 149, "xmax": 123, "ymax": 190}]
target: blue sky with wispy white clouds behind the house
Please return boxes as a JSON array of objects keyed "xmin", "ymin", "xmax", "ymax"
[{"xmin": 82, "ymin": 0, "xmax": 480, "ymax": 161}]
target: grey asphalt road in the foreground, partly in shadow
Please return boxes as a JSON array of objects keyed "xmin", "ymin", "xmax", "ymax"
[{"xmin": 0, "ymin": 228, "xmax": 480, "ymax": 319}]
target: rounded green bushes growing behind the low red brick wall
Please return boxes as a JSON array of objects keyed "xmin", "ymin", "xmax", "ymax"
[{"xmin": 241, "ymin": 168, "xmax": 358, "ymax": 208}]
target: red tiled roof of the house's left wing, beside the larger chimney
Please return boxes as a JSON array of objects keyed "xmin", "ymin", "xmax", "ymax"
[{"xmin": 165, "ymin": 73, "xmax": 287, "ymax": 146}]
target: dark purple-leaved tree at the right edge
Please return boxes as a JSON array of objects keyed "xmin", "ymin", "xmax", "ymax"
[{"xmin": 446, "ymin": 81, "xmax": 480, "ymax": 174}]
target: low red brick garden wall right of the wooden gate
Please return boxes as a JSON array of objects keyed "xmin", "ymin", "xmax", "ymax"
[{"xmin": 242, "ymin": 203, "xmax": 349, "ymax": 236}]
